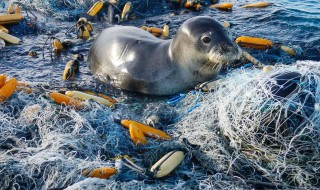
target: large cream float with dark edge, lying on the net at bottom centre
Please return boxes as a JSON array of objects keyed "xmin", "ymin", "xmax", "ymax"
[{"xmin": 150, "ymin": 151, "xmax": 184, "ymax": 178}]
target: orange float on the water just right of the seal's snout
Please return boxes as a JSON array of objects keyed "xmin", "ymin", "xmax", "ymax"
[{"xmin": 236, "ymin": 36, "xmax": 273, "ymax": 50}]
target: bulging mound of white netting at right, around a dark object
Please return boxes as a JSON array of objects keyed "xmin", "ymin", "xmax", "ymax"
[{"xmin": 177, "ymin": 61, "xmax": 320, "ymax": 188}]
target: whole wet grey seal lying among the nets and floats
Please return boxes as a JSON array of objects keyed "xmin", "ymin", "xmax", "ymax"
[{"xmin": 88, "ymin": 16, "xmax": 241, "ymax": 95}]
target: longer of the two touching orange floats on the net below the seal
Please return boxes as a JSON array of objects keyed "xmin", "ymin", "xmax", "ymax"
[{"xmin": 121, "ymin": 120, "xmax": 172, "ymax": 140}]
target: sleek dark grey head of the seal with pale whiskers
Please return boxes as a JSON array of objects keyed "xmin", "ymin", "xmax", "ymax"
[{"xmin": 170, "ymin": 16, "xmax": 241, "ymax": 75}]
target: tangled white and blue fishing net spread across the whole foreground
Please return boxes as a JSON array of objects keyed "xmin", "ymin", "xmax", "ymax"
[{"xmin": 0, "ymin": 61, "xmax": 320, "ymax": 189}]
